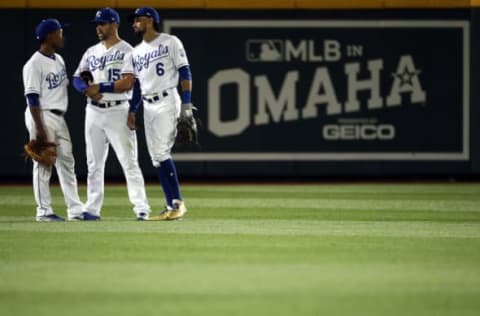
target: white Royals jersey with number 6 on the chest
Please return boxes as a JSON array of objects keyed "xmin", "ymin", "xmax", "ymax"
[{"xmin": 133, "ymin": 33, "xmax": 188, "ymax": 95}]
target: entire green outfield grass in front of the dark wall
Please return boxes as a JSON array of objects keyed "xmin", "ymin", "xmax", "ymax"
[{"xmin": 0, "ymin": 183, "xmax": 480, "ymax": 316}]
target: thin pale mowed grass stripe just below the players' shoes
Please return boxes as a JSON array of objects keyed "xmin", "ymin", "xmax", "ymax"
[{"xmin": 0, "ymin": 217, "xmax": 480, "ymax": 238}]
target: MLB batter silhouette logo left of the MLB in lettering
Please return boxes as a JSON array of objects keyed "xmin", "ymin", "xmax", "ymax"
[{"xmin": 247, "ymin": 39, "xmax": 283, "ymax": 62}]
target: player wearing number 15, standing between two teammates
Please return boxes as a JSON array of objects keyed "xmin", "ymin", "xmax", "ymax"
[{"xmin": 73, "ymin": 8, "xmax": 151, "ymax": 220}]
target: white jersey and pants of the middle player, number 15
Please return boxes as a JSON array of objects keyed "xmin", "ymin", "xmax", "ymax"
[{"xmin": 74, "ymin": 40, "xmax": 150, "ymax": 216}]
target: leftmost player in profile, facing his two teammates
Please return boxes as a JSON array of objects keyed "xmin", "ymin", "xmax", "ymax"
[{"xmin": 23, "ymin": 19, "xmax": 83, "ymax": 222}]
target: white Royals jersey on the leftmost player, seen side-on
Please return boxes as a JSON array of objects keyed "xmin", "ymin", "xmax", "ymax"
[{"xmin": 23, "ymin": 51, "xmax": 68, "ymax": 112}]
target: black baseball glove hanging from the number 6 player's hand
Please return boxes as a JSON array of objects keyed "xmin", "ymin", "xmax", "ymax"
[{"xmin": 175, "ymin": 103, "xmax": 199, "ymax": 147}]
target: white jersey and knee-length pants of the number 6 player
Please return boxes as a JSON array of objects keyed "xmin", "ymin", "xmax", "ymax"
[{"xmin": 133, "ymin": 33, "xmax": 188, "ymax": 167}]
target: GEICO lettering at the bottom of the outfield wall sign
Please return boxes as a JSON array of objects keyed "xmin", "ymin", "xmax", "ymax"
[{"xmin": 322, "ymin": 124, "xmax": 395, "ymax": 140}]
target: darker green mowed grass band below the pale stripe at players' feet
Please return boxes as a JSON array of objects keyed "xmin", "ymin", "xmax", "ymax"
[{"xmin": 0, "ymin": 232, "xmax": 480, "ymax": 264}]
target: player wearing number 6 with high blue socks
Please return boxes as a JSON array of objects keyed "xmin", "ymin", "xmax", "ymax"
[{"xmin": 130, "ymin": 7, "xmax": 193, "ymax": 220}]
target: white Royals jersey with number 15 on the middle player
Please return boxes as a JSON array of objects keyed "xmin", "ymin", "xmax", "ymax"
[{"xmin": 73, "ymin": 40, "xmax": 134, "ymax": 101}]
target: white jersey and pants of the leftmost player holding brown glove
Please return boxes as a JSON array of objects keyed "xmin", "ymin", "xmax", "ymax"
[{"xmin": 23, "ymin": 51, "xmax": 83, "ymax": 218}]
